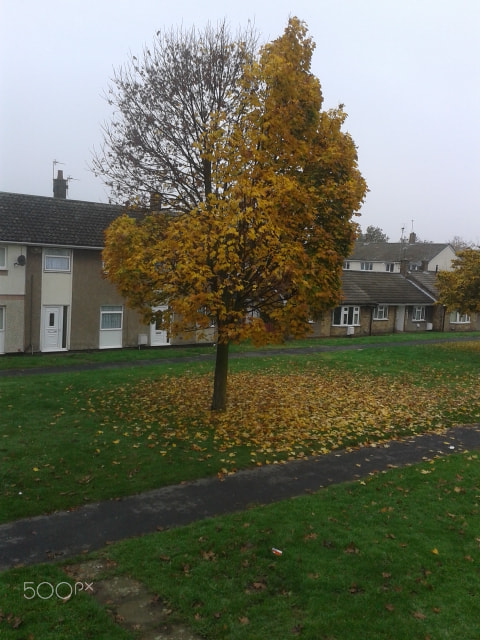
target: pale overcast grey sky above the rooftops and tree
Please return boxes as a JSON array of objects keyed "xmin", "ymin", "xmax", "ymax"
[{"xmin": 0, "ymin": 0, "xmax": 480, "ymax": 243}]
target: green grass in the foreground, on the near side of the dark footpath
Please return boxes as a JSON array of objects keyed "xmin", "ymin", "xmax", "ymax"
[{"xmin": 0, "ymin": 452, "xmax": 480, "ymax": 640}]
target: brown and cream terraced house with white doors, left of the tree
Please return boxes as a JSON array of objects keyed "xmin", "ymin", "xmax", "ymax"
[{"xmin": 0, "ymin": 171, "xmax": 208, "ymax": 353}]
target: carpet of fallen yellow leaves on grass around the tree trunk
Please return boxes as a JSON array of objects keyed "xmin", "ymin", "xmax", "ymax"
[{"xmin": 82, "ymin": 344, "xmax": 480, "ymax": 470}]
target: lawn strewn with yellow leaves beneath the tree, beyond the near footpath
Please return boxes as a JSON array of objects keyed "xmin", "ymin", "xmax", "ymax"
[{"xmin": 0, "ymin": 340, "xmax": 480, "ymax": 522}]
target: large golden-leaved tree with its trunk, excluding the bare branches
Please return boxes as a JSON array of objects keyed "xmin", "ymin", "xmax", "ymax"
[{"xmin": 99, "ymin": 18, "xmax": 366, "ymax": 410}]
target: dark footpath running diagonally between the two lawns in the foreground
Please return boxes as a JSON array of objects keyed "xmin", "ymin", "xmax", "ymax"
[{"xmin": 0, "ymin": 424, "xmax": 480, "ymax": 570}]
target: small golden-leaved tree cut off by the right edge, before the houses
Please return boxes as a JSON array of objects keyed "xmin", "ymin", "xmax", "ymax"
[{"xmin": 437, "ymin": 248, "xmax": 480, "ymax": 313}]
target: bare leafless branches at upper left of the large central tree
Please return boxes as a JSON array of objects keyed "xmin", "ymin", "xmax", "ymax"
[{"xmin": 92, "ymin": 22, "xmax": 257, "ymax": 208}]
